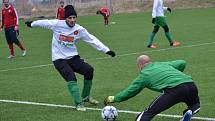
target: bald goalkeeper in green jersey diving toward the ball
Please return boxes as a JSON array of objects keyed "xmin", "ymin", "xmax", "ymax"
[{"xmin": 104, "ymin": 55, "xmax": 200, "ymax": 121}]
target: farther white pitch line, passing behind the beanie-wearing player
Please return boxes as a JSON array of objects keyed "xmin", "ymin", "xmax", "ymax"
[{"xmin": 0, "ymin": 42, "xmax": 215, "ymax": 72}]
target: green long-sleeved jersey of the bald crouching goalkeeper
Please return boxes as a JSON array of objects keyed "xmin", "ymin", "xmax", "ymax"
[{"xmin": 114, "ymin": 60, "xmax": 193, "ymax": 102}]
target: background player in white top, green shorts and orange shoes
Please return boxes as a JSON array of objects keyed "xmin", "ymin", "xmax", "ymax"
[{"xmin": 147, "ymin": 0, "xmax": 180, "ymax": 48}]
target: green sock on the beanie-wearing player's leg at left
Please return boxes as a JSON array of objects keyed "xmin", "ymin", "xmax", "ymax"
[{"xmin": 67, "ymin": 81, "xmax": 82, "ymax": 105}]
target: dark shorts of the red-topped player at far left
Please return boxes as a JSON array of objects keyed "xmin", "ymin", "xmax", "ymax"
[{"xmin": 4, "ymin": 26, "xmax": 19, "ymax": 45}]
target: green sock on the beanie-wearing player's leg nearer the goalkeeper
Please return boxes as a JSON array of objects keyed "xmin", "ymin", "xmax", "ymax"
[{"xmin": 81, "ymin": 80, "xmax": 92, "ymax": 98}]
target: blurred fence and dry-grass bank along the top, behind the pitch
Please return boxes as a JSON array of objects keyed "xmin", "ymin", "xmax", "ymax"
[{"xmin": 0, "ymin": 0, "xmax": 215, "ymax": 17}]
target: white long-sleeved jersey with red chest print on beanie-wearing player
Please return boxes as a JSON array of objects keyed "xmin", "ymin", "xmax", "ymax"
[{"xmin": 31, "ymin": 19, "xmax": 110, "ymax": 61}]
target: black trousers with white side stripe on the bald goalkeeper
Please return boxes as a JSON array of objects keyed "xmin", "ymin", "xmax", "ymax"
[{"xmin": 136, "ymin": 82, "xmax": 200, "ymax": 121}]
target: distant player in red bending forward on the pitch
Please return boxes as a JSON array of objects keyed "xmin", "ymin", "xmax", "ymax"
[{"xmin": 96, "ymin": 8, "xmax": 110, "ymax": 25}]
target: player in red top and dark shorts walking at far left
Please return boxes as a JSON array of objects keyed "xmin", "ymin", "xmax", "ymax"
[{"xmin": 1, "ymin": 0, "xmax": 26, "ymax": 58}]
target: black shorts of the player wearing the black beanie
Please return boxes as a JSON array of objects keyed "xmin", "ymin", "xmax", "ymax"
[{"xmin": 53, "ymin": 55, "xmax": 94, "ymax": 82}]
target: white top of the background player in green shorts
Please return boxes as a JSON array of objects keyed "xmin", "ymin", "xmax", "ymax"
[{"xmin": 152, "ymin": 0, "xmax": 167, "ymax": 18}]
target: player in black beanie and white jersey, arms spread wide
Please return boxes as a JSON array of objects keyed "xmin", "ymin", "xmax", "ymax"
[{"xmin": 25, "ymin": 5, "xmax": 115, "ymax": 111}]
